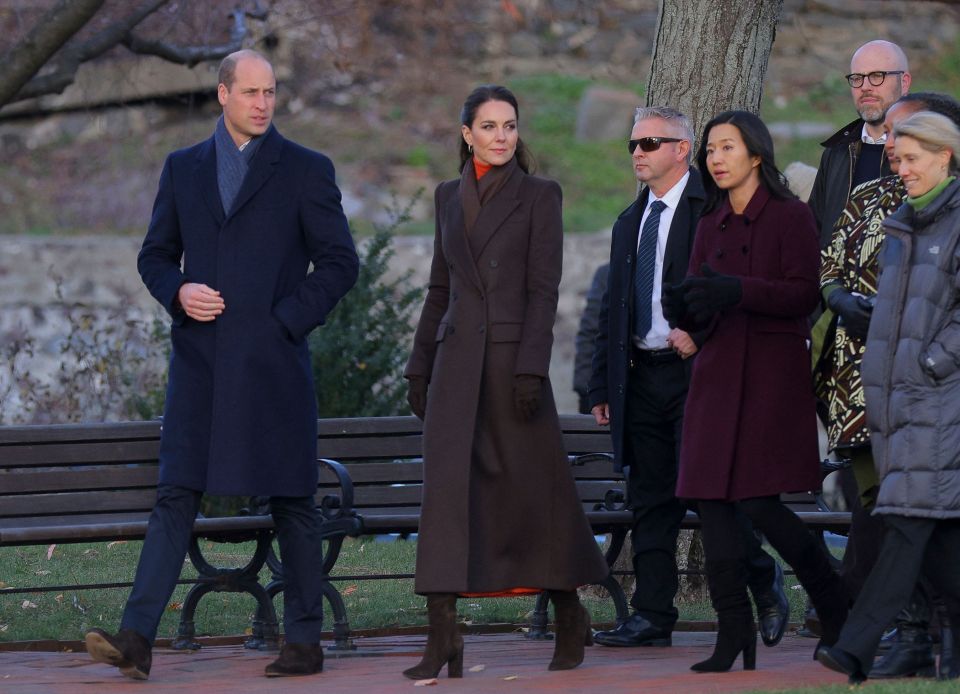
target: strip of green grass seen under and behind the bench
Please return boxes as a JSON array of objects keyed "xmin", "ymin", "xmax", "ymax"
[{"xmin": 0, "ymin": 538, "xmax": 806, "ymax": 641}]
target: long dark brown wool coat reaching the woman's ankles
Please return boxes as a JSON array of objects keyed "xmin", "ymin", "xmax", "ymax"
[{"xmin": 405, "ymin": 163, "xmax": 608, "ymax": 593}]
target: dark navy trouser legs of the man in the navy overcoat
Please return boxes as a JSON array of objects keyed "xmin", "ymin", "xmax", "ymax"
[{"xmin": 120, "ymin": 484, "xmax": 323, "ymax": 644}]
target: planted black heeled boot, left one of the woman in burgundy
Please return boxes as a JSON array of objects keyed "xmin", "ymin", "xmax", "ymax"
[{"xmin": 690, "ymin": 559, "xmax": 757, "ymax": 672}]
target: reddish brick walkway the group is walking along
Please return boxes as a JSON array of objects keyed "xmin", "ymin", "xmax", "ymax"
[{"xmin": 0, "ymin": 632, "xmax": 845, "ymax": 694}]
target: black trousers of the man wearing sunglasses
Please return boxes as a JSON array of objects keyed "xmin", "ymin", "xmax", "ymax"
[{"xmin": 624, "ymin": 351, "xmax": 776, "ymax": 631}]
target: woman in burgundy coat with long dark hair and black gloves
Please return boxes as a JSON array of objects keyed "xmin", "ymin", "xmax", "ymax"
[{"xmin": 664, "ymin": 111, "xmax": 846, "ymax": 671}]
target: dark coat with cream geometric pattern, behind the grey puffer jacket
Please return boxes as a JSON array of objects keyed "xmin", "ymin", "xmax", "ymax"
[{"xmin": 816, "ymin": 176, "xmax": 906, "ymax": 450}]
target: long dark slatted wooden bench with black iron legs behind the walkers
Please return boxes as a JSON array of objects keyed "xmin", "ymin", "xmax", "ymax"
[{"xmin": 0, "ymin": 415, "xmax": 849, "ymax": 648}]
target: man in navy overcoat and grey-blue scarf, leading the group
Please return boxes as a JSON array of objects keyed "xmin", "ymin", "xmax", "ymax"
[{"xmin": 86, "ymin": 50, "xmax": 358, "ymax": 679}]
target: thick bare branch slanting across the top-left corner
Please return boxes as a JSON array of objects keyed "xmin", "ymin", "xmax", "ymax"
[{"xmin": 0, "ymin": 0, "xmax": 104, "ymax": 104}]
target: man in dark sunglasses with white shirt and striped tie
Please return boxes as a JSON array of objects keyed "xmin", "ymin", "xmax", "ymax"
[{"xmin": 589, "ymin": 107, "xmax": 789, "ymax": 646}]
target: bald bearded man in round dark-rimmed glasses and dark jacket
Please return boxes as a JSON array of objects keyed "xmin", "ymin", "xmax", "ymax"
[{"xmin": 810, "ymin": 39, "xmax": 911, "ymax": 248}]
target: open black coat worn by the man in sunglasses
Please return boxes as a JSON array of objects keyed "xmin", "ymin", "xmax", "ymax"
[{"xmin": 590, "ymin": 168, "xmax": 706, "ymax": 470}]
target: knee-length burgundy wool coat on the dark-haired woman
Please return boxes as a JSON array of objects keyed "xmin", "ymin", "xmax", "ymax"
[{"xmin": 677, "ymin": 185, "xmax": 820, "ymax": 501}]
